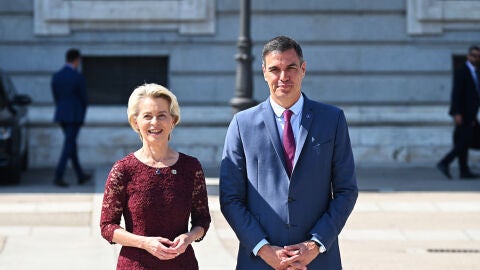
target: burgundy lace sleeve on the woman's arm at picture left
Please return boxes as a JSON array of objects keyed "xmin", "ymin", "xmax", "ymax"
[{"xmin": 100, "ymin": 162, "xmax": 126, "ymax": 244}]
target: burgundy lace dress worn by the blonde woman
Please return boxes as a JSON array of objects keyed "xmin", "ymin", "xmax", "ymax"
[{"xmin": 100, "ymin": 153, "xmax": 211, "ymax": 270}]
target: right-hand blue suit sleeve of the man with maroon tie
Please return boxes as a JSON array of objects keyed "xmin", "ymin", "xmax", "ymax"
[{"xmin": 310, "ymin": 109, "xmax": 358, "ymax": 250}]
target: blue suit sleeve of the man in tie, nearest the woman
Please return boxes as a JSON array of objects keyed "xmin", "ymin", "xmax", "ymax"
[{"xmin": 220, "ymin": 117, "xmax": 268, "ymax": 253}]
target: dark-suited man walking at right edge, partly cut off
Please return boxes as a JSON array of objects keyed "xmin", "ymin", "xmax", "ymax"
[{"xmin": 437, "ymin": 46, "xmax": 480, "ymax": 179}]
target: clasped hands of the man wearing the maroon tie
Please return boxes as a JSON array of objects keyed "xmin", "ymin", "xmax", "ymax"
[{"xmin": 281, "ymin": 240, "xmax": 320, "ymax": 270}]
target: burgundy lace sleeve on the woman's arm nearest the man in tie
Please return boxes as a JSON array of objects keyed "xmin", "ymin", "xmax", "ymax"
[{"xmin": 191, "ymin": 161, "xmax": 211, "ymax": 242}]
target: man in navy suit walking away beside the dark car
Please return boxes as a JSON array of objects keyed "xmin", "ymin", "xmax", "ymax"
[{"xmin": 51, "ymin": 49, "xmax": 91, "ymax": 187}]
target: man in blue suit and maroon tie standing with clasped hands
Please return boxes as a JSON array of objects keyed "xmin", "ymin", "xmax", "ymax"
[{"xmin": 220, "ymin": 36, "xmax": 358, "ymax": 270}]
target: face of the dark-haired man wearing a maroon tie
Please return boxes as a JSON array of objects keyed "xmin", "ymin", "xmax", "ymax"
[{"xmin": 262, "ymin": 49, "xmax": 306, "ymax": 108}]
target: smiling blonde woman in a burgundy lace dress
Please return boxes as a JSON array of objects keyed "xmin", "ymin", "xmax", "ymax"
[{"xmin": 100, "ymin": 84, "xmax": 211, "ymax": 270}]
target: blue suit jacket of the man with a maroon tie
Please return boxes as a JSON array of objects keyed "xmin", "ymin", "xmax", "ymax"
[{"xmin": 220, "ymin": 94, "xmax": 358, "ymax": 270}]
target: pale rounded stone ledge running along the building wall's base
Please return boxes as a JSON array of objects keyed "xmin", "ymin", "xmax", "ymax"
[{"xmin": 28, "ymin": 104, "xmax": 451, "ymax": 128}]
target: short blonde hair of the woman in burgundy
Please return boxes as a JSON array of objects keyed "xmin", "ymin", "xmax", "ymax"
[{"xmin": 127, "ymin": 83, "xmax": 180, "ymax": 139}]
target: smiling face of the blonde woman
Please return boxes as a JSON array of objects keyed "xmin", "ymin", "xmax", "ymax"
[{"xmin": 135, "ymin": 97, "xmax": 174, "ymax": 144}]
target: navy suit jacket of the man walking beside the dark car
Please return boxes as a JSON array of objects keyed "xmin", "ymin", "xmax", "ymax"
[{"xmin": 51, "ymin": 66, "xmax": 87, "ymax": 124}]
